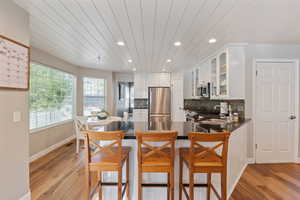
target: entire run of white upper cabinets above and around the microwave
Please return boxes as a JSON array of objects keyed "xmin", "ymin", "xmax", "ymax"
[{"xmin": 184, "ymin": 45, "xmax": 245, "ymax": 99}]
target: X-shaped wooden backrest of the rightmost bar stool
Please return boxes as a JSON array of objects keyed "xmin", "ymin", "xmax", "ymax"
[{"xmin": 188, "ymin": 131, "xmax": 230, "ymax": 168}]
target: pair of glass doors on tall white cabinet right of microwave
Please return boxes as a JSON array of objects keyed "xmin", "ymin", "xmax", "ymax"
[{"xmin": 211, "ymin": 51, "xmax": 228, "ymax": 99}]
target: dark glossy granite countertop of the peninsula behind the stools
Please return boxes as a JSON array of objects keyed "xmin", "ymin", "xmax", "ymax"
[{"xmin": 93, "ymin": 119, "xmax": 250, "ymax": 139}]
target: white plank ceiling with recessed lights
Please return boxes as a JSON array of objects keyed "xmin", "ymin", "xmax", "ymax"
[{"xmin": 15, "ymin": 0, "xmax": 300, "ymax": 72}]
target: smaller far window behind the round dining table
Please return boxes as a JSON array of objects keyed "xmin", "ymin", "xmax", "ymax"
[{"xmin": 83, "ymin": 78, "xmax": 106, "ymax": 116}]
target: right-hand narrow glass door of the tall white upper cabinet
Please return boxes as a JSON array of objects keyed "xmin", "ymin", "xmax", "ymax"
[{"xmin": 217, "ymin": 52, "xmax": 228, "ymax": 96}]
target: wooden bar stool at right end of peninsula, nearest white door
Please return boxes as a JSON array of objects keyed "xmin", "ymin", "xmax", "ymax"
[{"xmin": 179, "ymin": 132, "xmax": 230, "ymax": 200}]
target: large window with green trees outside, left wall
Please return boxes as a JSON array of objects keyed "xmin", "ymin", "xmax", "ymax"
[{"xmin": 29, "ymin": 63, "xmax": 75, "ymax": 129}]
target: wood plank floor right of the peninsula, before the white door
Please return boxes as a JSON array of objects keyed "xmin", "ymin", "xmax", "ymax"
[{"xmin": 230, "ymin": 163, "xmax": 300, "ymax": 200}]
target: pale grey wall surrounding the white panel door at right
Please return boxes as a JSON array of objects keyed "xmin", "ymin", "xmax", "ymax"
[{"xmin": 246, "ymin": 44, "xmax": 300, "ymax": 157}]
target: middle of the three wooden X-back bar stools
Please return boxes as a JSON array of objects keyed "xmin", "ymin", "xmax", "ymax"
[{"xmin": 136, "ymin": 132, "xmax": 177, "ymax": 200}]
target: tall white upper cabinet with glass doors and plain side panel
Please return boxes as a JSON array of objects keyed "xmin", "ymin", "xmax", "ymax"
[{"xmin": 210, "ymin": 46, "xmax": 245, "ymax": 99}]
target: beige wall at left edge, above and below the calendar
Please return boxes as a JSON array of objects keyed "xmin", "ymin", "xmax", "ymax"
[{"xmin": 0, "ymin": 0, "xmax": 30, "ymax": 200}]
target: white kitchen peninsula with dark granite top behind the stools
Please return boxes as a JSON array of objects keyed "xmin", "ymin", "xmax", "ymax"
[{"xmin": 95, "ymin": 119, "xmax": 250, "ymax": 200}]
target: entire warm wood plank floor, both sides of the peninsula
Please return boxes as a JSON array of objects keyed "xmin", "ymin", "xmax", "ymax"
[{"xmin": 30, "ymin": 142, "xmax": 300, "ymax": 200}]
